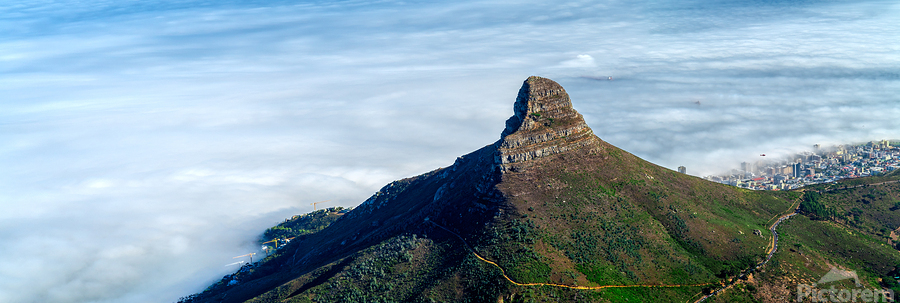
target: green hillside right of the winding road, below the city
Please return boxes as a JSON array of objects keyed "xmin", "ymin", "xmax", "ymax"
[{"xmin": 713, "ymin": 172, "xmax": 900, "ymax": 302}]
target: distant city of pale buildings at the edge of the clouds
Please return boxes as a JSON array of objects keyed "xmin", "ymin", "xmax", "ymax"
[{"xmin": 696, "ymin": 140, "xmax": 900, "ymax": 190}]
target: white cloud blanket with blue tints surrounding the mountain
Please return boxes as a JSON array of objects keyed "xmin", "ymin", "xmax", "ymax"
[{"xmin": 0, "ymin": 1, "xmax": 900, "ymax": 302}]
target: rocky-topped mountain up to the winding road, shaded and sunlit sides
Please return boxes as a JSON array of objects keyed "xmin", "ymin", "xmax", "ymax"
[{"xmin": 183, "ymin": 77, "xmax": 900, "ymax": 302}]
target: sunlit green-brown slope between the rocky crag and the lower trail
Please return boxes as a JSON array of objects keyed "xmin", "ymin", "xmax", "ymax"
[{"xmin": 488, "ymin": 141, "xmax": 797, "ymax": 285}]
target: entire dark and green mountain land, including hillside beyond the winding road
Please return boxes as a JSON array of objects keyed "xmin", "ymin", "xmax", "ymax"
[{"xmin": 181, "ymin": 77, "xmax": 900, "ymax": 303}]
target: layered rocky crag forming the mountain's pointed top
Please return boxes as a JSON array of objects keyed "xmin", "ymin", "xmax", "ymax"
[{"xmin": 497, "ymin": 76, "xmax": 597, "ymax": 170}]
